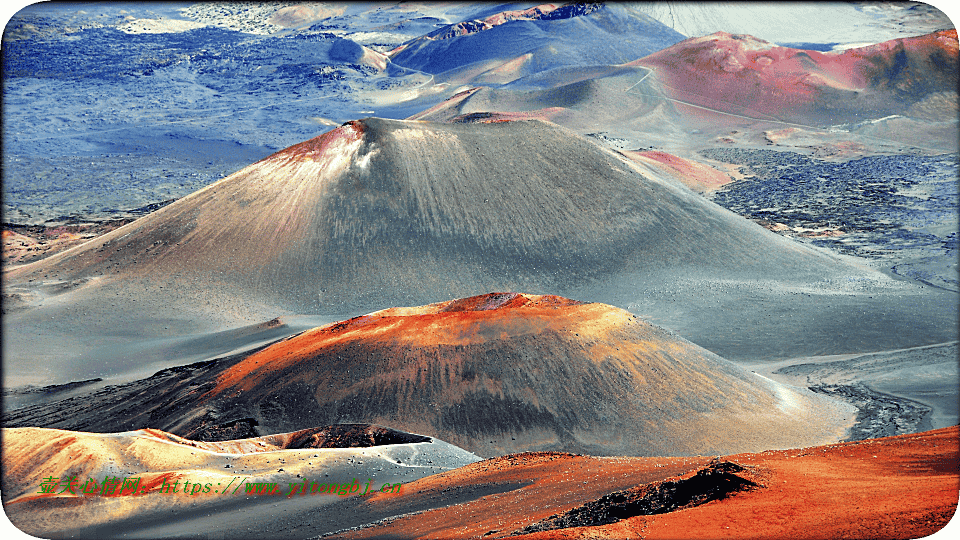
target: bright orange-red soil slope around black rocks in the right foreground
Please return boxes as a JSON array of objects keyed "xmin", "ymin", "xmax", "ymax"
[{"xmin": 343, "ymin": 427, "xmax": 960, "ymax": 540}]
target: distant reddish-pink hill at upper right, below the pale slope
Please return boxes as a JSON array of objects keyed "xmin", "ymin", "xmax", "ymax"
[{"xmin": 629, "ymin": 29, "xmax": 958, "ymax": 123}]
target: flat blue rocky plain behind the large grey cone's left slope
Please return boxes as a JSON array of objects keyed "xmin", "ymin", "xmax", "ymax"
[{"xmin": 3, "ymin": 4, "xmax": 425, "ymax": 223}]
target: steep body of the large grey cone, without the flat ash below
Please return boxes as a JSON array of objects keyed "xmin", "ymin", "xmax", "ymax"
[{"xmin": 7, "ymin": 118, "xmax": 884, "ymax": 313}]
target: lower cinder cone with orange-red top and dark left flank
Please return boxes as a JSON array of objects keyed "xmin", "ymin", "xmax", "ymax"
[{"xmin": 5, "ymin": 293, "xmax": 853, "ymax": 456}]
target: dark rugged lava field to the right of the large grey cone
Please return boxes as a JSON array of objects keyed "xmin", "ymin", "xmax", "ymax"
[{"xmin": 701, "ymin": 148, "xmax": 958, "ymax": 259}]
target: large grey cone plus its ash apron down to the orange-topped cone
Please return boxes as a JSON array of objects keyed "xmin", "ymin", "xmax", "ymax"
[{"xmin": 3, "ymin": 118, "xmax": 955, "ymax": 385}]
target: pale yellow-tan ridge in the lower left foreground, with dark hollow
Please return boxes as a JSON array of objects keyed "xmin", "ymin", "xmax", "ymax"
[{"xmin": 3, "ymin": 425, "xmax": 479, "ymax": 538}]
